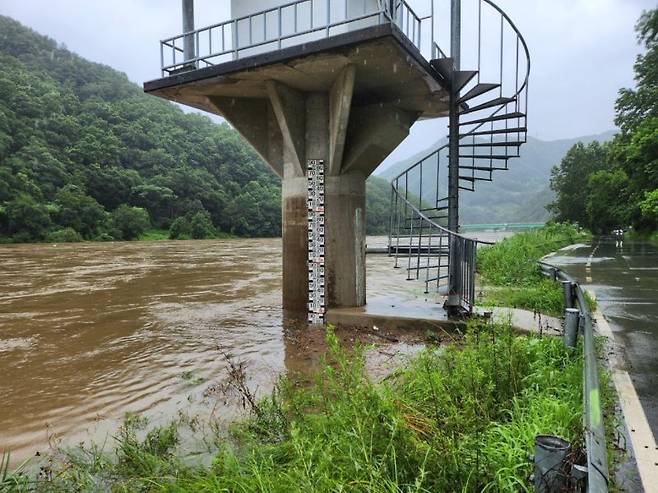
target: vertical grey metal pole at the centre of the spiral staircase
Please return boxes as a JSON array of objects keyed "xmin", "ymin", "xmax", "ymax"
[{"xmin": 446, "ymin": 0, "xmax": 463, "ymax": 313}]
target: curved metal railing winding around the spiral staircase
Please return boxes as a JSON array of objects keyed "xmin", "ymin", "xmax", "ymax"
[{"xmin": 388, "ymin": 0, "xmax": 530, "ymax": 311}]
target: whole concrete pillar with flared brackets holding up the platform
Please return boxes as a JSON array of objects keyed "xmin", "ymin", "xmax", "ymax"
[{"xmin": 208, "ymin": 73, "xmax": 418, "ymax": 319}]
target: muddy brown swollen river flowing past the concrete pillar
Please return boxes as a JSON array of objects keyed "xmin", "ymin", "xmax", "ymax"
[{"xmin": 0, "ymin": 239, "xmax": 440, "ymax": 464}]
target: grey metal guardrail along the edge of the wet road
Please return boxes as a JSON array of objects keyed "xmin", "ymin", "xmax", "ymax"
[{"xmin": 539, "ymin": 262, "xmax": 609, "ymax": 493}]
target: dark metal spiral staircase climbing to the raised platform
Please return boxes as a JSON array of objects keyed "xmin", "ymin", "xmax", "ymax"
[{"xmin": 388, "ymin": 0, "xmax": 530, "ymax": 313}]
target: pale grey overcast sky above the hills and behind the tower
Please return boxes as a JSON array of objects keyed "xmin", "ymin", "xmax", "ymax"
[{"xmin": 0, "ymin": 0, "xmax": 656, "ymax": 164}]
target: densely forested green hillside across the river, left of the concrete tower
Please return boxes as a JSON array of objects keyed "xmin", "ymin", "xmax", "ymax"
[{"xmin": 0, "ymin": 16, "xmax": 388, "ymax": 242}]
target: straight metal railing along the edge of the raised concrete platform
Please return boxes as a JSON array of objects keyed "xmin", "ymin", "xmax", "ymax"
[{"xmin": 160, "ymin": 0, "xmax": 434, "ymax": 76}]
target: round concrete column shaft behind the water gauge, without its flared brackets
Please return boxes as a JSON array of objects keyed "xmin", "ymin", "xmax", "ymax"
[{"xmin": 275, "ymin": 93, "xmax": 366, "ymax": 317}]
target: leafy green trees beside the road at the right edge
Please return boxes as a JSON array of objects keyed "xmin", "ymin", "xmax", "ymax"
[{"xmin": 549, "ymin": 9, "xmax": 658, "ymax": 233}]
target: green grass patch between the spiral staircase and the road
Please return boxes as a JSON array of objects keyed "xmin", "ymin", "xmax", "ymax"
[{"xmin": 477, "ymin": 224, "xmax": 590, "ymax": 316}]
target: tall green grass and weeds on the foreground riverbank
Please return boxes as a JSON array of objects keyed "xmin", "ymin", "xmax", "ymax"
[{"xmin": 5, "ymin": 324, "xmax": 583, "ymax": 493}]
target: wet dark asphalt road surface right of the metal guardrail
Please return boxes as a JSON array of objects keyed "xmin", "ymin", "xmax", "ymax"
[{"xmin": 550, "ymin": 238, "xmax": 658, "ymax": 437}]
